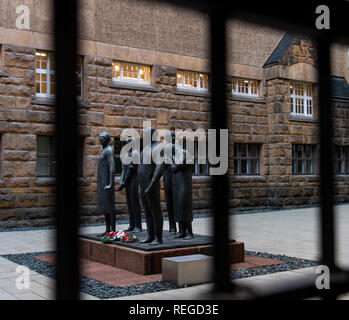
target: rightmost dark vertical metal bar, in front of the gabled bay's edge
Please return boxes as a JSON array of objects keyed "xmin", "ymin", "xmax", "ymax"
[{"xmin": 317, "ymin": 37, "xmax": 335, "ymax": 269}]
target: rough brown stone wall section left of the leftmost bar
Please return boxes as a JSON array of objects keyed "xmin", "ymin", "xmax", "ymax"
[{"xmin": 0, "ymin": 45, "xmax": 54, "ymax": 227}]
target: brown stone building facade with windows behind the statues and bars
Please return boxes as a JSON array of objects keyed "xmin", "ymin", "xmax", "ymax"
[{"xmin": 0, "ymin": 0, "xmax": 349, "ymax": 228}]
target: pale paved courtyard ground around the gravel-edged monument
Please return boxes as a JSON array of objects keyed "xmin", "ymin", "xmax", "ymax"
[{"xmin": 0, "ymin": 205, "xmax": 349, "ymax": 300}]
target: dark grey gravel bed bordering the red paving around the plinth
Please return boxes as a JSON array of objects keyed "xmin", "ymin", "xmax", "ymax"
[{"xmin": 2, "ymin": 251, "xmax": 318, "ymax": 299}]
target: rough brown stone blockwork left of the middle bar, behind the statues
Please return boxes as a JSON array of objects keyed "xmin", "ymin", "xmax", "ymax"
[{"xmin": 0, "ymin": 45, "xmax": 210, "ymax": 227}]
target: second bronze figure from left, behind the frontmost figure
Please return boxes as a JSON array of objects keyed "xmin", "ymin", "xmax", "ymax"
[{"xmin": 118, "ymin": 137, "xmax": 142, "ymax": 232}]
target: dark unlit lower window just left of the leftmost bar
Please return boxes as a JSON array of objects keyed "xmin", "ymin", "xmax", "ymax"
[{"xmin": 36, "ymin": 136, "xmax": 56, "ymax": 177}]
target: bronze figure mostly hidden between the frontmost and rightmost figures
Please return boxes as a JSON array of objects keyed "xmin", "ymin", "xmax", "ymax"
[{"xmin": 163, "ymin": 131, "xmax": 177, "ymax": 233}]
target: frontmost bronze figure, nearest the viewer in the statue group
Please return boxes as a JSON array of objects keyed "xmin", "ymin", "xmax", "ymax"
[{"xmin": 138, "ymin": 127, "xmax": 164, "ymax": 245}]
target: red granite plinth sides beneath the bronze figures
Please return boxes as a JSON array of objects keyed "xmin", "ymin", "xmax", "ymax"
[{"xmin": 79, "ymin": 238, "xmax": 244, "ymax": 275}]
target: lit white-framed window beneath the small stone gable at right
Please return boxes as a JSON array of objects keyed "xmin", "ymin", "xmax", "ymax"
[{"xmin": 290, "ymin": 82, "xmax": 314, "ymax": 117}]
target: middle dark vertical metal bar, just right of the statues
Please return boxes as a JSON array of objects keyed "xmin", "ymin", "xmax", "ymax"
[{"xmin": 210, "ymin": 5, "xmax": 232, "ymax": 291}]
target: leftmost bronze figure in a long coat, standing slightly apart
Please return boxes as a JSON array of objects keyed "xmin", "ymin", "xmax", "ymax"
[{"xmin": 97, "ymin": 132, "xmax": 116, "ymax": 233}]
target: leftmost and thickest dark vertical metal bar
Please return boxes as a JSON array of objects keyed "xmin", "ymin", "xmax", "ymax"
[{"xmin": 54, "ymin": 0, "xmax": 79, "ymax": 300}]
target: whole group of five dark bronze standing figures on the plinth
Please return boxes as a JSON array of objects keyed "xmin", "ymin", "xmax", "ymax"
[{"xmin": 97, "ymin": 127, "xmax": 194, "ymax": 245}]
